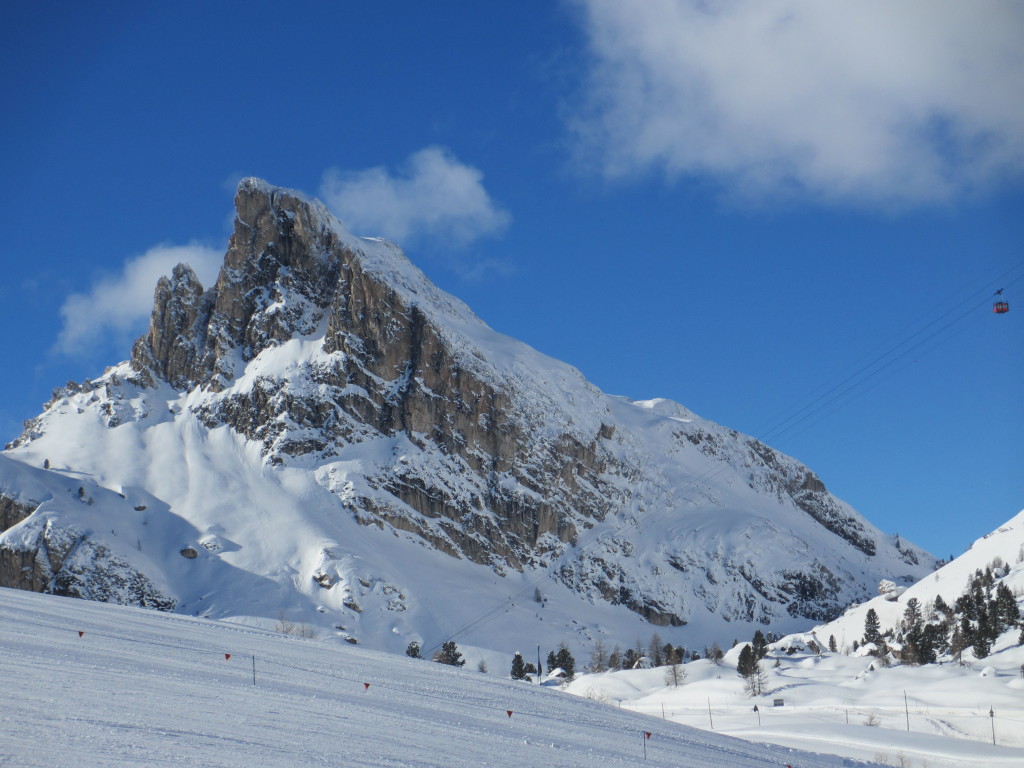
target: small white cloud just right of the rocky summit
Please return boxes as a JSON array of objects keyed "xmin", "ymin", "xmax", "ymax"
[{"xmin": 319, "ymin": 146, "xmax": 510, "ymax": 246}]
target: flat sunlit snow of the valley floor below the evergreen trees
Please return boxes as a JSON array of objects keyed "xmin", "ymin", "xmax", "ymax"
[{"xmin": 568, "ymin": 630, "xmax": 1024, "ymax": 768}]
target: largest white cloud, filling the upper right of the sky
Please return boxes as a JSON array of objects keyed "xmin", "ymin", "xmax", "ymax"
[{"xmin": 572, "ymin": 0, "xmax": 1024, "ymax": 205}]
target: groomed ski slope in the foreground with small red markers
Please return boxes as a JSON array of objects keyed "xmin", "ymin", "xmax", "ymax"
[{"xmin": 0, "ymin": 589, "xmax": 868, "ymax": 768}]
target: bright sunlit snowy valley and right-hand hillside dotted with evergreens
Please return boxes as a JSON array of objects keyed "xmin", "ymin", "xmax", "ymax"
[{"xmin": 568, "ymin": 512, "xmax": 1024, "ymax": 768}]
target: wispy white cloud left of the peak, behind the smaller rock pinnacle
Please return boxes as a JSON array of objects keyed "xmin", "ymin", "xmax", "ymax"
[{"xmin": 54, "ymin": 243, "xmax": 224, "ymax": 356}]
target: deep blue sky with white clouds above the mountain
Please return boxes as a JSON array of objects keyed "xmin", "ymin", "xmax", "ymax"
[{"xmin": 0, "ymin": 0, "xmax": 1024, "ymax": 557}]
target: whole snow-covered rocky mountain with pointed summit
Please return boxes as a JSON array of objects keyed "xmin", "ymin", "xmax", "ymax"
[{"xmin": 0, "ymin": 179, "xmax": 935, "ymax": 651}]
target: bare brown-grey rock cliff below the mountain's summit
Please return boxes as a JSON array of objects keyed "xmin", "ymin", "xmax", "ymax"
[{"xmin": 124, "ymin": 180, "xmax": 613, "ymax": 569}]
